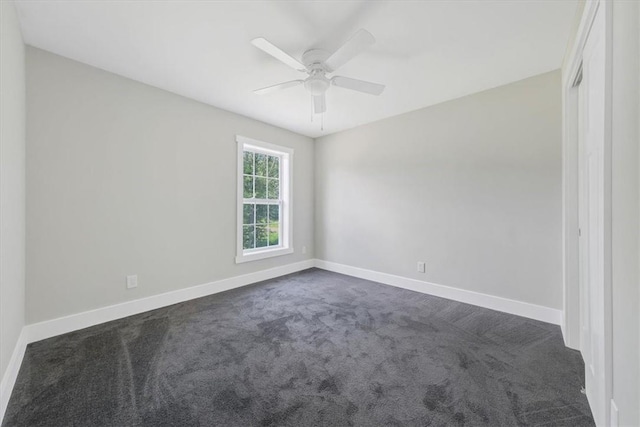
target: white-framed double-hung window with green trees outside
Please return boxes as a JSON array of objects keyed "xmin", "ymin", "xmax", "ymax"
[{"xmin": 236, "ymin": 135, "xmax": 293, "ymax": 263}]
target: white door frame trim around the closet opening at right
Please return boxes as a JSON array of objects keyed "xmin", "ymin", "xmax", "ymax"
[{"xmin": 562, "ymin": 0, "xmax": 613, "ymax": 423}]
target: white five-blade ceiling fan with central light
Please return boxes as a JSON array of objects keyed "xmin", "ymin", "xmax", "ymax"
[{"xmin": 251, "ymin": 29, "xmax": 384, "ymax": 114}]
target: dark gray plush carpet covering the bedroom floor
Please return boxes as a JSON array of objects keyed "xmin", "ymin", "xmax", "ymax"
[{"xmin": 3, "ymin": 269, "xmax": 593, "ymax": 426}]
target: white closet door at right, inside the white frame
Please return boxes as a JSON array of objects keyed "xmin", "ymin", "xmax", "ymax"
[{"xmin": 580, "ymin": 5, "xmax": 607, "ymax": 425}]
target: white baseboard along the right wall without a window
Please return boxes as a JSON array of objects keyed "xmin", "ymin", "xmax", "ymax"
[{"xmin": 315, "ymin": 259, "xmax": 562, "ymax": 325}]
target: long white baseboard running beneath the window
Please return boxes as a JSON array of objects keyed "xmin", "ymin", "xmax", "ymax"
[{"xmin": 25, "ymin": 259, "xmax": 314, "ymax": 342}]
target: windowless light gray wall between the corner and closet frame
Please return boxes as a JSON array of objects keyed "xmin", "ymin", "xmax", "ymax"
[{"xmin": 315, "ymin": 71, "xmax": 562, "ymax": 309}]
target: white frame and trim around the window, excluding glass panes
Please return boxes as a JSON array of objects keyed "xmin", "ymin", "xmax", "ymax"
[{"xmin": 236, "ymin": 135, "xmax": 293, "ymax": 264}]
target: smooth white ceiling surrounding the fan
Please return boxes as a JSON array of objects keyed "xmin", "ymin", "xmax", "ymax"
[{"xmin": 17, "ymin": 0, "xmax": 577, "ymax": 137}]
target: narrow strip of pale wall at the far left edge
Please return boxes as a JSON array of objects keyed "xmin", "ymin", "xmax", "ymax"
[{"xmin": 0, "ymin": 1, "xmax": 25, "ymax": 384}]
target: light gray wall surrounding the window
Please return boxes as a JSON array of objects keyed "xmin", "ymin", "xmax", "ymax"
[{"xmin": 27, "ymin": 48, "xmax": 314, "ymax": 323}]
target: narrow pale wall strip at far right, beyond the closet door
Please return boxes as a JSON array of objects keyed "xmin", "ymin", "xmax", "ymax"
[{"xmin": 611, "ymin": 1, "xmax": 640, "ymax": 426}]
